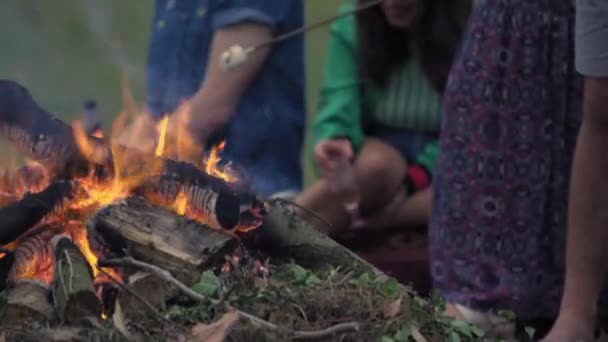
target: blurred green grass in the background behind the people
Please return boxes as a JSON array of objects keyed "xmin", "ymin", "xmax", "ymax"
[{"xmin": 0, "ymin": 0, "xmax": 341, "ymax": 182}]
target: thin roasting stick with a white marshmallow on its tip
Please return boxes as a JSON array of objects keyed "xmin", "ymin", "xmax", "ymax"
[{"xmin": 220, "ymin": 0, "xmax": 382, "ymax": 71}]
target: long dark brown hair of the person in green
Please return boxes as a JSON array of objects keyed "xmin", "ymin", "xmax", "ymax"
[{"xmin": 356, "ymin": 0, "xmax": 473, "ymax": 92}]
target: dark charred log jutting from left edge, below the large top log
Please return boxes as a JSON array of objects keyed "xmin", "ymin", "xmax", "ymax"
[{"xmin": 0, "ymin": 181, "xmax": 80, "ymax": 245}]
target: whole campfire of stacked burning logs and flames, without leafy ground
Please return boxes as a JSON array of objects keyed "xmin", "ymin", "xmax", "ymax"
[{"xmin": 0, "ymin": 81, "xmax": 265, "ymax": 323}]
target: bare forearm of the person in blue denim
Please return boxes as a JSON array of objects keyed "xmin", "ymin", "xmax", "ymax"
[{"xmin": 191, "ymin": 22, "xmax": 272, "ymax": 134}]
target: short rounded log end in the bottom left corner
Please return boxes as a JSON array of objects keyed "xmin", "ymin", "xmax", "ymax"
[{"xmin": 0, "ymin": 280, "xmax": 56, "ymax": 325}]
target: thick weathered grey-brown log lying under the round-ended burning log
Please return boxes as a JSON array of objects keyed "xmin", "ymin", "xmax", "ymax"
[{"xmin": 87, "ymin": 197, "xmax": 238, "ymax": 283}]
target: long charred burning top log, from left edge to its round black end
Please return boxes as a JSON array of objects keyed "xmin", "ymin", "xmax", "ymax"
[{"xmin": 0, "ymin": 80, "xmax": 264, "ymax": 229}]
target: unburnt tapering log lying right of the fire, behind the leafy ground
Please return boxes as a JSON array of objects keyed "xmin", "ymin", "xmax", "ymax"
[{"xmin": 255, "ymin": 200, "xmax": 390, "ymax": 275}]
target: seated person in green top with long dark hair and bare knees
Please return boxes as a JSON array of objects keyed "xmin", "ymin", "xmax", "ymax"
[{"xmin": 296, "ymin": 0, "xmax": 472, "ymax": 233}]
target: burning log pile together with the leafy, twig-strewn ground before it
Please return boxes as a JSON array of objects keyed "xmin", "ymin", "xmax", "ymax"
[{"xmin": 0, "ymin": 81, "xmax": 484, "ymax": 341}]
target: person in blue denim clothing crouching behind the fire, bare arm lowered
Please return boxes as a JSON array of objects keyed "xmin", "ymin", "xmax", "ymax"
[{"xmin": 147, "ymin": 0, "xmax": 306, "ymax": 196}]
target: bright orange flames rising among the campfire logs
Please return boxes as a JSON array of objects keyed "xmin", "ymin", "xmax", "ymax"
[{"xmin": 0, "ymin": 93, "xmax": 250, "ymax": 283}]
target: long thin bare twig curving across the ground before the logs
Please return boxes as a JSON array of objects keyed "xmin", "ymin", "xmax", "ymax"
[{"xmin": 98, "ymin": 257, "xmax": 360, "ymax": 340}]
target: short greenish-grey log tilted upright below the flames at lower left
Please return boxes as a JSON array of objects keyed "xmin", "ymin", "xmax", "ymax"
[{"xmin": 51, "ymin": 235, "xmax": 102, "ymax": 323}]
